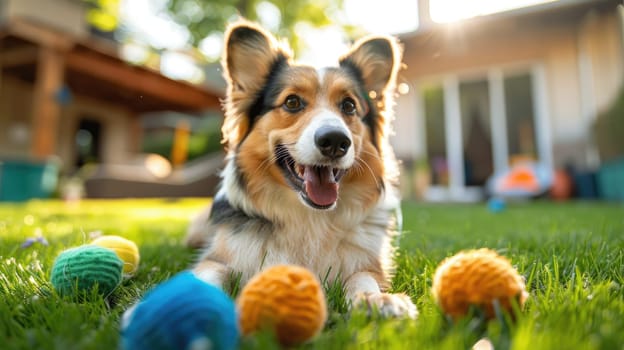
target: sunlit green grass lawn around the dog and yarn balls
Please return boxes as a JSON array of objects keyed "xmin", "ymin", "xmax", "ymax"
[{"xmin": 0, "ymin": 200, "xmax": 624, "ymax": 349}]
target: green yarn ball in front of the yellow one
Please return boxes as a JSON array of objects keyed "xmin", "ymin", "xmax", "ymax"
[{"xmin": 50, "ymin": 245, "xmax": 123, "ymax": 296}]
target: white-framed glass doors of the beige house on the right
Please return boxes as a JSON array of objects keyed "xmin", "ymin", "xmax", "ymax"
[{"xmin": 420, "ymin": 66, "xmax": 550, "ymax": 201}]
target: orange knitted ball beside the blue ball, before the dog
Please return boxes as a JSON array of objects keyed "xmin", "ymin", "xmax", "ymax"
[{"xmin": 237, "ymin": 265, "xmax": 327, "ymax": 346}]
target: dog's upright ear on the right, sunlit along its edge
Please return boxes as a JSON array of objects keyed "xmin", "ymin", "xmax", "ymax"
[{"xmin": 340, "ymin": 36, "xmax": 401, "ymax": 97}]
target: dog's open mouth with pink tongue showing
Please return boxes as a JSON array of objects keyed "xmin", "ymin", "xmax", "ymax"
[{"xmin": 275, "ymin": 145, "xmax": 345, "ymax": 209}]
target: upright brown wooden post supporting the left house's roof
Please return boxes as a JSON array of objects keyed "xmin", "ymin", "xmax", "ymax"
[{"xmin": 31, "ymin": 46, "xmax": 65, "ymax": 159}]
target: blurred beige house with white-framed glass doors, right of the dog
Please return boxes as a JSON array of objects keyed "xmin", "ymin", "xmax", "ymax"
[{"xmin": 393, "ymin": 0, "xmax": 624, "ymax": 201}]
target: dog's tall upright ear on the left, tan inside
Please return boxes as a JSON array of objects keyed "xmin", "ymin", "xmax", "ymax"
[{"xmin": 221, "ymin": 21, "xmax": 290, "ymax": 147}]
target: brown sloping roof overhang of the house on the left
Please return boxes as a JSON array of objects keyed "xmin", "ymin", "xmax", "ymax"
[{"xmin": 0, "ymin": 19, "xmax": 222, "ymax": 113}]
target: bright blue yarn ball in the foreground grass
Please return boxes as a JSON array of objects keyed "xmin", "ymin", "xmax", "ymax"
[{"xmin": 121, "ymin": 271, "xmax": 239, "ymax": 350}]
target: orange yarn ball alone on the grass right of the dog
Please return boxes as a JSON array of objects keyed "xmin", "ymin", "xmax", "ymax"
[{"xmin": 432, "ymin": 248, "xmax": 529, "ymax": 320}]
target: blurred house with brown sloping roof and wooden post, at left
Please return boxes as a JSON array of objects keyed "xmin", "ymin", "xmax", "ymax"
[{"xmin": 0, "ymin": 0, "xmax": 221, "ymax": 201}]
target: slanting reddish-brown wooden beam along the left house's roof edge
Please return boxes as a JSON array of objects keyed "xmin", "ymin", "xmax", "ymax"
[{"xmin": 66, "ymin": 50, "xmax": 220, "ymax": 111}]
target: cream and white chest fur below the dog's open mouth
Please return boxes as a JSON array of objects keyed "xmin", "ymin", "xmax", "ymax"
[{"xmin": 205, "ymin": 172, "xmax": 398, "ymax": 283}]
